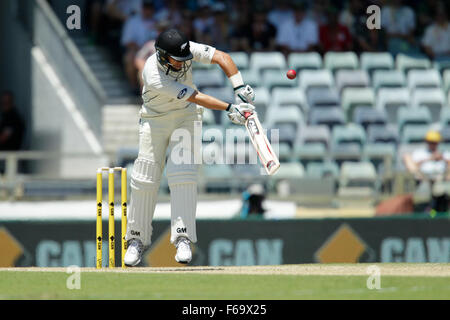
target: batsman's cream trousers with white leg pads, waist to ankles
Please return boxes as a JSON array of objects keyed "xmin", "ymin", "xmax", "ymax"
[{"xmin": 126, "ymin": 104, "xmax": 203, "ymax": 246}]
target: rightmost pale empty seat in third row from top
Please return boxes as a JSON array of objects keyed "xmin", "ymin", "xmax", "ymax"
[{"xmin": 411, "ymin": 88, "xmax": 447, "ymax": 122}]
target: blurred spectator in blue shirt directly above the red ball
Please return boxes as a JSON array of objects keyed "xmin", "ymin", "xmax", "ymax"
[{"xmin": 276, "ymin": 3, "xmax": 319, "ymax": 56}]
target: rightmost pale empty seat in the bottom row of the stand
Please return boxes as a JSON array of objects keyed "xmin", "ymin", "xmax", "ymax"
[{"xmin": 339, "ymin": 162, "xmax": 377, "ymax": 189}]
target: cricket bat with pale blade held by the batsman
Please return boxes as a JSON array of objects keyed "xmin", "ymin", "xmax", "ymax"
[{"xmin": 244, "ymin": 112, "xmax": 280, "ymax": 175}]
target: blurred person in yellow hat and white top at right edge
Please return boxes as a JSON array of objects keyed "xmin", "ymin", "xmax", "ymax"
[{"xmin": 403, "ymin": 130, "xmax": 450, "ymax": 212}]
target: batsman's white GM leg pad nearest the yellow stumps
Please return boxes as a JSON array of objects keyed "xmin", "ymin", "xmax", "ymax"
[{"xmin": 125, "ymin": 158, "xmax": 161, "ymax": 246}]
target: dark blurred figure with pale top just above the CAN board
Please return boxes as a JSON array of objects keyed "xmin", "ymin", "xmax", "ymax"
[{"xmin": 240, "ymin": 184, "xmax": 266, "ymax": 219}]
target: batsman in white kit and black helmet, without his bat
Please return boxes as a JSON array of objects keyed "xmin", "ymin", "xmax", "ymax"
[{"xmin": 125, "ymin": 29, "xmax": 255, "ymax": 266}]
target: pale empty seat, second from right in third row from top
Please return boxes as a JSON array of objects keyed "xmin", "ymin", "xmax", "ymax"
[{"xmin": 376, "ymin": 88, "xmax": 411, "ymax": 123}]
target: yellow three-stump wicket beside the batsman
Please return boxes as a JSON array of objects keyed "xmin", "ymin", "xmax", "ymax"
[{"xmin": 96, "ymin": 167, "xmax": 127, "ymax": 269}]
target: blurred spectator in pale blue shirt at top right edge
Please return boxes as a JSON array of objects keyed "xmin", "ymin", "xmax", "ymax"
[{"xmin": 422, "ymin": 4, "xmax": 450, "ymax": 59}]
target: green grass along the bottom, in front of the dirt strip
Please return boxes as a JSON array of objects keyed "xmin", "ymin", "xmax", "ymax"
[{"xmin": 0, "ymin": 264, "xmax": 450, "ymax": 300}]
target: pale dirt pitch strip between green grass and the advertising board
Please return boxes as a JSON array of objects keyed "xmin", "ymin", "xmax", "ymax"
[{"xmin": 0, "ymin": 263, "xmax": 450, "ymax": 277}]
